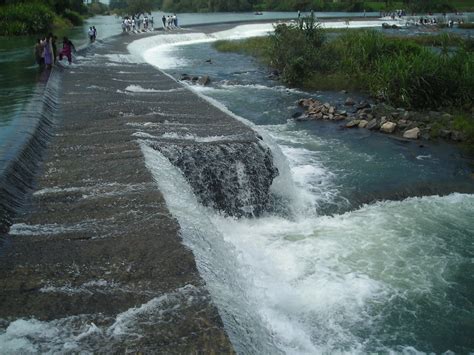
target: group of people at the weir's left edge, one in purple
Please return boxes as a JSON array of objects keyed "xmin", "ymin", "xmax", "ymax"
[{"xmin": 34, "ymin": 33, "xmax": 76, "ymax": 69}]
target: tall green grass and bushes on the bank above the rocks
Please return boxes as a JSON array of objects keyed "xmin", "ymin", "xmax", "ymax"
[{"xmin": 215, "ymin": 20, "xmax": 474, "ymax": 141}]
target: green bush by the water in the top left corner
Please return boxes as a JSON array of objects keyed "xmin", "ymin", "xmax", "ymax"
[{"xmin": 0, "ymin": 2, "xmax": 54, "ymax": 36}]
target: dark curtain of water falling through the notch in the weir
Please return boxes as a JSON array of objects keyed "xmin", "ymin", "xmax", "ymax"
[{"xmin": 152, "ymin": 142, "xmax": 278, "ymax": 217}]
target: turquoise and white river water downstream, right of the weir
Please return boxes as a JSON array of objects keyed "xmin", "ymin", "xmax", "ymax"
[{"xmin": 0, "ymin": 12, "xmax": 474, "ymax": 354}]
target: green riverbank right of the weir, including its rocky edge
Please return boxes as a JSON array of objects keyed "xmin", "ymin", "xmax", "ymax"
[{"xmin": 215, "ymin": 18, "xmax": 474, "ymax": 144}]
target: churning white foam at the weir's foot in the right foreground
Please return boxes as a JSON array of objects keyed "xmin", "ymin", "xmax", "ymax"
[{"xmin": 142, "ymin": 136, "xmax": 474, "ymax": 354}]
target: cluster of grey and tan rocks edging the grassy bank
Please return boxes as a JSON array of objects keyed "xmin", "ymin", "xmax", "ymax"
[{"xmin": 293, "ymin": 97, "xmax": 466, "ymax": 141}]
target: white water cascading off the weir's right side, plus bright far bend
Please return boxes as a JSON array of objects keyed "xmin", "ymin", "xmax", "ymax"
[{"xmin": 135, "ymin": 23, "xmax": 474, "ymax": 354}]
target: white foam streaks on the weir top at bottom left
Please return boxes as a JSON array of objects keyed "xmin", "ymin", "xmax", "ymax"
[{"xmin": 0, "ymin": 288, "xmax": 202, "ymax": 354}]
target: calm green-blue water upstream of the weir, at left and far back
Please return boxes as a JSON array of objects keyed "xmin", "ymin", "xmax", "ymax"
[{"xmin": 0, "ymin": 12, "xmax": 372, "ymax": 161}]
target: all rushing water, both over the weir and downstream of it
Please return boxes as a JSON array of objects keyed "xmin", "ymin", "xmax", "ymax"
[{"xmin": 0, "ymin": 20, "xmax": 474, "ymax": 354}]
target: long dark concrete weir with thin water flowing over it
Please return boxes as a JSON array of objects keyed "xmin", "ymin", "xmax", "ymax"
[{"xmin": 0, "ymin": 32, "xmax": 276, "ymax": 353}]
